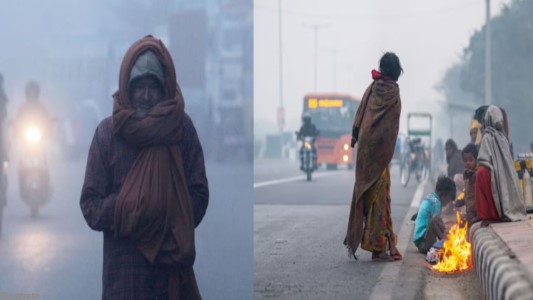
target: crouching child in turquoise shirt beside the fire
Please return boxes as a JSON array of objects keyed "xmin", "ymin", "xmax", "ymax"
[{"xmin": 413, "ymin": 176, "xmax": 456, "ymax": 254}]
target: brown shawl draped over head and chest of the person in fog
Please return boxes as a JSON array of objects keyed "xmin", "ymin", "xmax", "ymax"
[{"xmin": 113, "ymin": 36, "xmax": 200, "ymax": 299}]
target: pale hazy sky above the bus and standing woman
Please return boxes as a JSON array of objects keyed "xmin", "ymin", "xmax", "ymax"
[{"xmin": 254, "ymin": 0, "xmax": 510, "ymax": 138}]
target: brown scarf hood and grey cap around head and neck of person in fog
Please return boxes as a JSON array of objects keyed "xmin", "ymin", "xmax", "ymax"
[{"xmin": 113, "ymin": 35, "xmax": 185, "ymax": 143}]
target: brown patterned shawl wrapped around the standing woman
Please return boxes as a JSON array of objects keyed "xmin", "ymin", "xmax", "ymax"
[{"xmin": 345, "ymin": 79, "xmax": 401, "ymax": 255}]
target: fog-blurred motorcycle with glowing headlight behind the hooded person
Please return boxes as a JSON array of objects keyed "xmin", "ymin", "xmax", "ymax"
[{"xmin": 18, "ymin": 125, "xmax": 51, "ymax": 218}]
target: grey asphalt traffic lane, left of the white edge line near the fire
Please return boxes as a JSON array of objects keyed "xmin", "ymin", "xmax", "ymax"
[{"xmin": 254, "ymin": 160, "xmax": 417, "ymax": 299}]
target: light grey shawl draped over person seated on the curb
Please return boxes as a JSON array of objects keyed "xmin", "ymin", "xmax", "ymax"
[{"xmin": 477, "ymin": 105, "xmax": 527, "ymax": 221}]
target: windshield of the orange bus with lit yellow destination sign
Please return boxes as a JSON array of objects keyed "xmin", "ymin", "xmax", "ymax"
[{"xmin": 304, "ymin": 97, "xmax": 359, "ymax": 136}]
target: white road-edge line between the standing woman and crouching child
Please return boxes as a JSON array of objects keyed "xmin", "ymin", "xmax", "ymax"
[{"xmin": 370, "ymin": 178, "xmax": 428, "ymax": 300}]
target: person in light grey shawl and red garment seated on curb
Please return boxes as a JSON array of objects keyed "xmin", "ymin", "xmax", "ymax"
[{"xmin": 475, "ymin": 105, "xmax": 527, "ymax": 226}]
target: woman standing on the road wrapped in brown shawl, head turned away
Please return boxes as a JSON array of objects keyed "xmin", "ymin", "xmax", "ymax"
[{"xmin": 344, "ymin": 52, "xmax": 403, "ymax": 261}]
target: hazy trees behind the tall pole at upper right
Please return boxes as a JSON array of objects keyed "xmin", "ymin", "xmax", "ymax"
[{"xmin": 439, "ymin": 0, "xmax": 533, "ymax": 152}]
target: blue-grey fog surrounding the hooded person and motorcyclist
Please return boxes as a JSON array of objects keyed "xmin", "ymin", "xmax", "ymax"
[{"xmin": 0, "ymin": 0, "xmax": 253, "ymax": 299}]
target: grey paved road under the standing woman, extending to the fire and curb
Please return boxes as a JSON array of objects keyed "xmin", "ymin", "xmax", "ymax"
[{"xmin": 254, "ymin": 160, "xmax": 482, "ymax": 299}]
